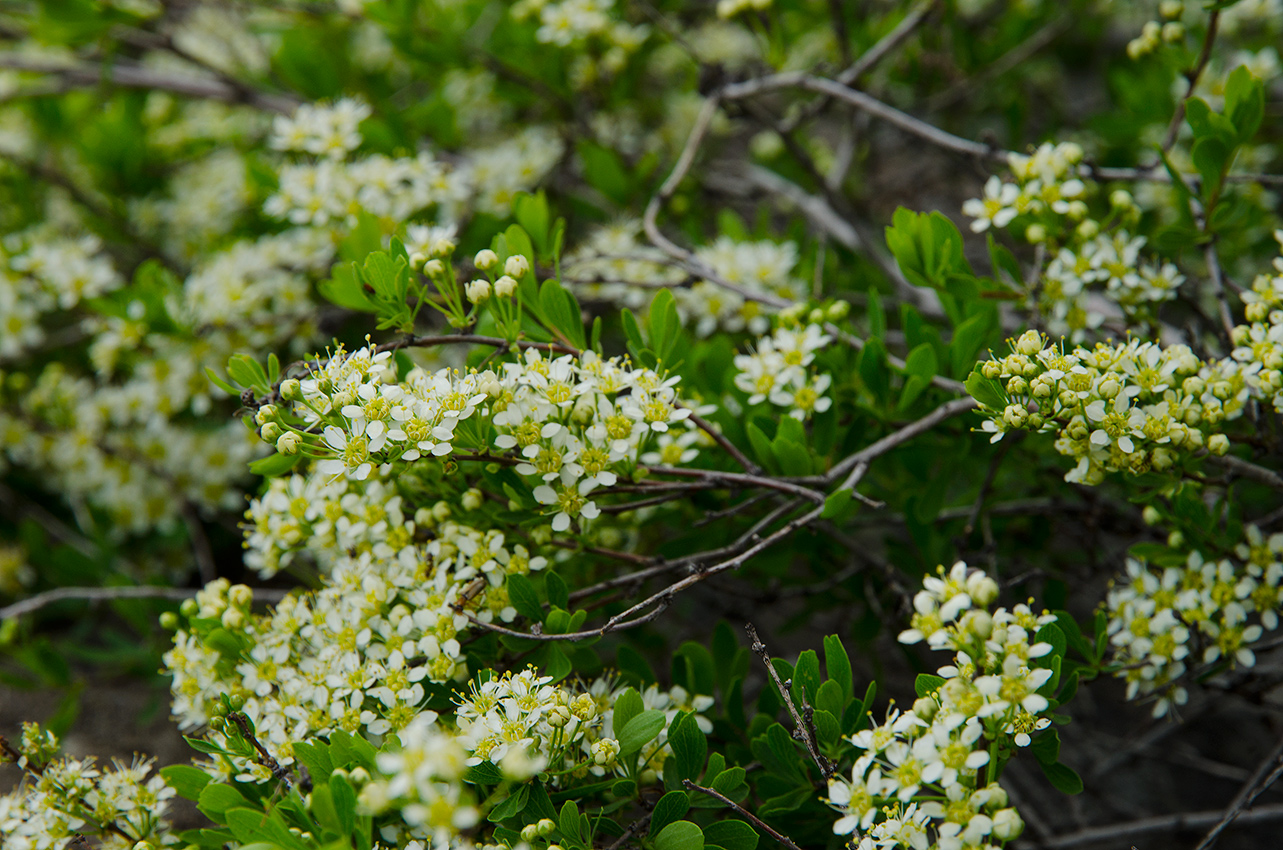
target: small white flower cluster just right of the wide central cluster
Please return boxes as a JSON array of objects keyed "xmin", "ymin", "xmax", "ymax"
[{"xmin": 735, "ymin": 324, "xmax": 833, "ymax": 419}]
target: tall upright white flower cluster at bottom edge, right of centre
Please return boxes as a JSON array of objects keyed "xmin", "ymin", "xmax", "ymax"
[{"xmin": 826, "ymin": 562, "xmax": 1055, "ymax": 850}]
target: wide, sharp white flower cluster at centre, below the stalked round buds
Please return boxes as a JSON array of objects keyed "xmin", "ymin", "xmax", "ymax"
[{"xmin": 257, "ymin": 338, "xmax": 694, "ymax": 531}]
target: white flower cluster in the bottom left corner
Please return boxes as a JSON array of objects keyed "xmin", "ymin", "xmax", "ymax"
[{"xmin": 0, "ymin": 723, "xmax": 174, "ymax": 850}]
